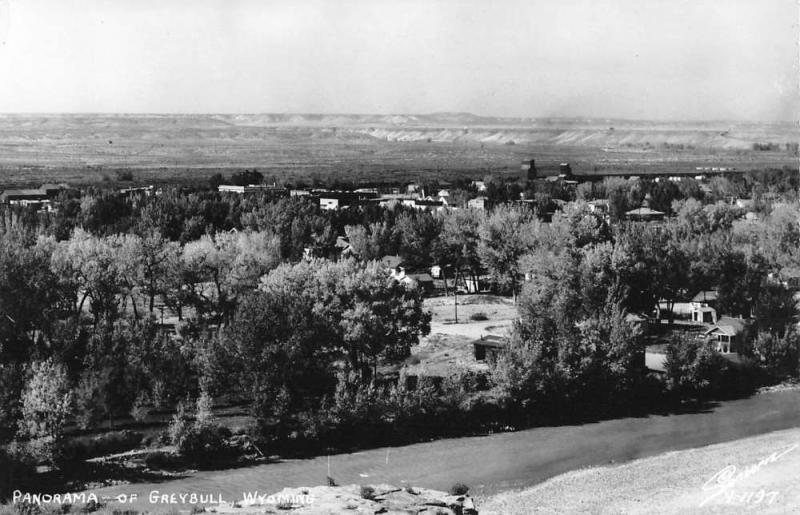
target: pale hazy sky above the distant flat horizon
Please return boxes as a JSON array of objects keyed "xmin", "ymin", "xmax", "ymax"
[{"xmin": 0, "ymin": 0, "xmax": 800, "ymax": 120}]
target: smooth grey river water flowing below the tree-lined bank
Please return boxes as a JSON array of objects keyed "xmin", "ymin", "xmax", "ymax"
[{"xmin": 70, "ymin": 390, "xmax": 800, "ymax": 510}]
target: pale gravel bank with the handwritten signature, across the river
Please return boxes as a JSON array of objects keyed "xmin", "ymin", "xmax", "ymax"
[{"xmin": 480, "ymin": 429, "xmax": 800, "ymax": 515}]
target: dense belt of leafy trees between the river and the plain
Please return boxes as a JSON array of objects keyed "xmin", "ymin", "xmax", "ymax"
[{"xmin": 0, "ymin": 172, "xmax": 800, "ymax": 490}]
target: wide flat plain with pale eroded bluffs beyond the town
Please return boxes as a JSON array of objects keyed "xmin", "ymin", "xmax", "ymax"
[{"xmin": 0, "ymin": 113, "xmax": 800, "ymax": 188}]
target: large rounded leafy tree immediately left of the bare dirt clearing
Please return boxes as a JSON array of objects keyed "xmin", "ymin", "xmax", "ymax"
[{"xmin": 225, "ymin": 259, "xmax": 430, "ymax": 434}]
